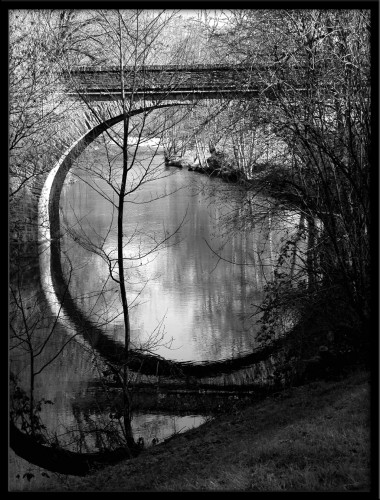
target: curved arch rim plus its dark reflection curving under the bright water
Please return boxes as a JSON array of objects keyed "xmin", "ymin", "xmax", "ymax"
[{"xmin": 38, "ymin": 102, "xmax": 284, "ymax": 385}]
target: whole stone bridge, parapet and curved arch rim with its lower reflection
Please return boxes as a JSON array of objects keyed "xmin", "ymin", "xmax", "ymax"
[{"xmin": 11, "ymin": 66, "xmax": 300, "ymax": 385}]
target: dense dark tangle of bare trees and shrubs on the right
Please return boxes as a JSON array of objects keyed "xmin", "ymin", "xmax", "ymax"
[{"xmin": 200, "ymin": 9, "xmax": 371, "ymax": 360}]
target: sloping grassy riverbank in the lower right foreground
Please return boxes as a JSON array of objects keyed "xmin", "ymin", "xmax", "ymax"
[{"xmin": 40, "ymin": 370, "xmax": 371, "ymax": 491}]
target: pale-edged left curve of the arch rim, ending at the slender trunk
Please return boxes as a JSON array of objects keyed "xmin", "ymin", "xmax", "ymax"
[{"xmin": 38, "ymin": 102, "xmax": 190, "ymax": 371}]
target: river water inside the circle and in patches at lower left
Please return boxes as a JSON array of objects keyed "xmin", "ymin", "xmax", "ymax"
[{"xmin": 10, "ymin": 140, "xmax": 302, "ymax": 490}]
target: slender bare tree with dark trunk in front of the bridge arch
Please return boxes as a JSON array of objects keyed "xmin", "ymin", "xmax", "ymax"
[{"xmin": 55, "ymin": 10, "xmax": 202, "ymax": 448}]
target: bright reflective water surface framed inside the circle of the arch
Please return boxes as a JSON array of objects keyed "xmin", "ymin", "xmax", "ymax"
[{"xmin": 61, "ymin": 139, "xmax": 298, "ymax": 361}]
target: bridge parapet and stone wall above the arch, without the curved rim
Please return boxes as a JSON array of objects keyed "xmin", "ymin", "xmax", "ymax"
[{"xmin": 11, "ymin": 65, "xmax": 268, "ymax": 255}]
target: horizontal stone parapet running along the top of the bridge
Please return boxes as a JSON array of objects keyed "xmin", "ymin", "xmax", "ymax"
[{"xmin": 63, "ymin": 64, "xmax": 294, "ymax": 101}]
